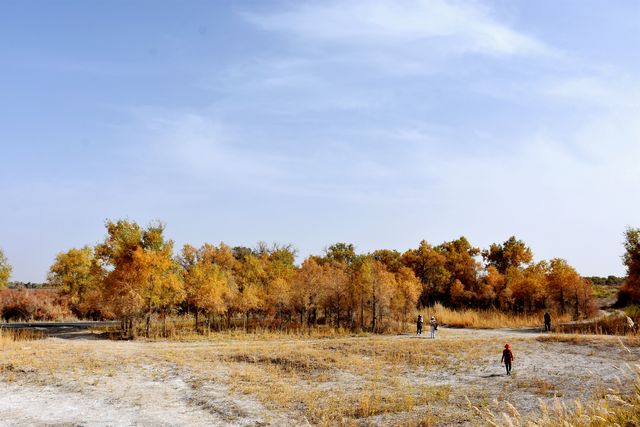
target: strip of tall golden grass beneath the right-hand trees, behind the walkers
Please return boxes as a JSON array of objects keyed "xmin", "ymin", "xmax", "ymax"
[{"xmin": 416, "ymin": 304, "xmax": 571, "ymax": 329}]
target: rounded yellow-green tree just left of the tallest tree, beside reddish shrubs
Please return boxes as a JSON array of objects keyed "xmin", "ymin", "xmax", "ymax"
[{"xmin": 47, "ymin": 246, "xmax": 100, "ymax": 317}]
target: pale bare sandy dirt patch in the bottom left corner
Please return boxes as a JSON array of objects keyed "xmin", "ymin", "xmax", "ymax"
[{"xmin": 0, "ymin": 365, "xmax": 284, "ymax": 426}]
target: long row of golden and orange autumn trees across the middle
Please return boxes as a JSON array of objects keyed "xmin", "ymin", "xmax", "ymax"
[{"xmin": 42, "ymin": 220, "xmax": 593, "ymax": 334}]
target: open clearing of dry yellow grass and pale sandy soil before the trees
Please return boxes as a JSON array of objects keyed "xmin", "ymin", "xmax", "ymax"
[{"xmin": 0, "ymin": 328, "xmax": 640, "ymax": 426}]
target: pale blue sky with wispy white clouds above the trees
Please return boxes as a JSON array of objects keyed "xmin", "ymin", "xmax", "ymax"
[{"xmin": 0, "ymin": 0, "xmax": 640, "ymax": 282}]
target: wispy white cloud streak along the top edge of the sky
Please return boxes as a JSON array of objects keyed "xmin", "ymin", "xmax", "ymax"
[{"xmin": 245, "ymin": 0, "xmax": 550, "ymax": 55}]
